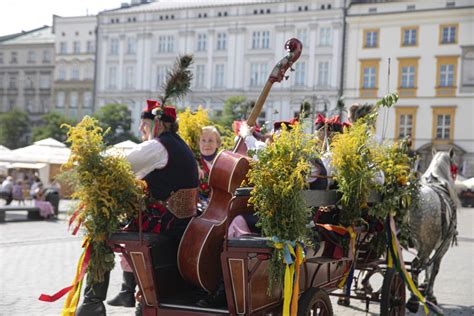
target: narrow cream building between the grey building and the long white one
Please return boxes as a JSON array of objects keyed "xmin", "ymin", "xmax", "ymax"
[{"xmin": 52, "ymin": 15, "xmax": 97, "ymax": 119}]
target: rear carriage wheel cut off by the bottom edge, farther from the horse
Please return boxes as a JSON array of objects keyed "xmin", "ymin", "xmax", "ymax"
[{"xmin": 298, "ymin": 287, "xmax": 333, "ymax": 316}]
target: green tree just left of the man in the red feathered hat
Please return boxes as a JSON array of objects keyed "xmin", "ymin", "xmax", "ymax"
[{"xmin": 94, "ymin": 104, "xmax": 139, "ymax": 145}]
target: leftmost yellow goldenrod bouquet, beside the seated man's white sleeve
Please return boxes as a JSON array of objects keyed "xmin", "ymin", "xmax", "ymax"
[{"xmin": 63, "ymin": 116, "xmax": 145, "ymax": 283}]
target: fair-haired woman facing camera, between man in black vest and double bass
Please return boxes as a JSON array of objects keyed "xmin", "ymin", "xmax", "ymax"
[{"xmin": 196, "ymin": 126, "xmax": 222, "ymax": 205}]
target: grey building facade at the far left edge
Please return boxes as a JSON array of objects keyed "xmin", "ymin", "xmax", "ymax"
[{"xmin": 0, "ymin": 26, "xmax": 54, "ymax": 126}]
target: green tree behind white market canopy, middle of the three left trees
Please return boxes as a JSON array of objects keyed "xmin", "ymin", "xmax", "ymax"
[{"xmin": 32, "ymin": 112, "xmax": 76, "ymax": 142}]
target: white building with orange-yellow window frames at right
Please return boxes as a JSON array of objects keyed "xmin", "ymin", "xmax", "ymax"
[{"xmin": 344, "ymin": 0, "xmax": 474, "ymax": 177}]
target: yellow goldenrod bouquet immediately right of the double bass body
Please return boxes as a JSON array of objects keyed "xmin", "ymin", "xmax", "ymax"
[{"xmin": 244, "ymin": 124, "xmax": 317, "ymax": 288}]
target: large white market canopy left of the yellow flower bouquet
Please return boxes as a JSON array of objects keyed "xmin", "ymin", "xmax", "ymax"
[{"xmin": 0, "ymin": 138, "xmax": 71, "ymax": 164}]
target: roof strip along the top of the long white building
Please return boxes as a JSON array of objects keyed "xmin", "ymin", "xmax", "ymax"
[{"xmin": 101, "ymin": 0, "xmax": 283, "ymax": 14}]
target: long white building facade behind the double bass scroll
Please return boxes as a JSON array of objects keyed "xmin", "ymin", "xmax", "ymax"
[{"xmin": 95, "ymin": 0, "xmax": 344, "ymax": 130}]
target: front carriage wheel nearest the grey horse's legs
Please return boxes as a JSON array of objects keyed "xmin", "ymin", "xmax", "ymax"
[{"xmin": 380, "ymin": 268, "xmax": 406, "ymax": 316}]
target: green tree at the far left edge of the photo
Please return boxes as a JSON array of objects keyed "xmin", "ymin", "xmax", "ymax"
[{"xmin": 0, "ymin": 109, "xmax": 30, "ymax": 149}]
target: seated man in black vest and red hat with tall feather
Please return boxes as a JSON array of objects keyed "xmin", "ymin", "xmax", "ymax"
[{"xmin": 76, "ymin": 56, "xmax": 199, "ymax": 316}]
